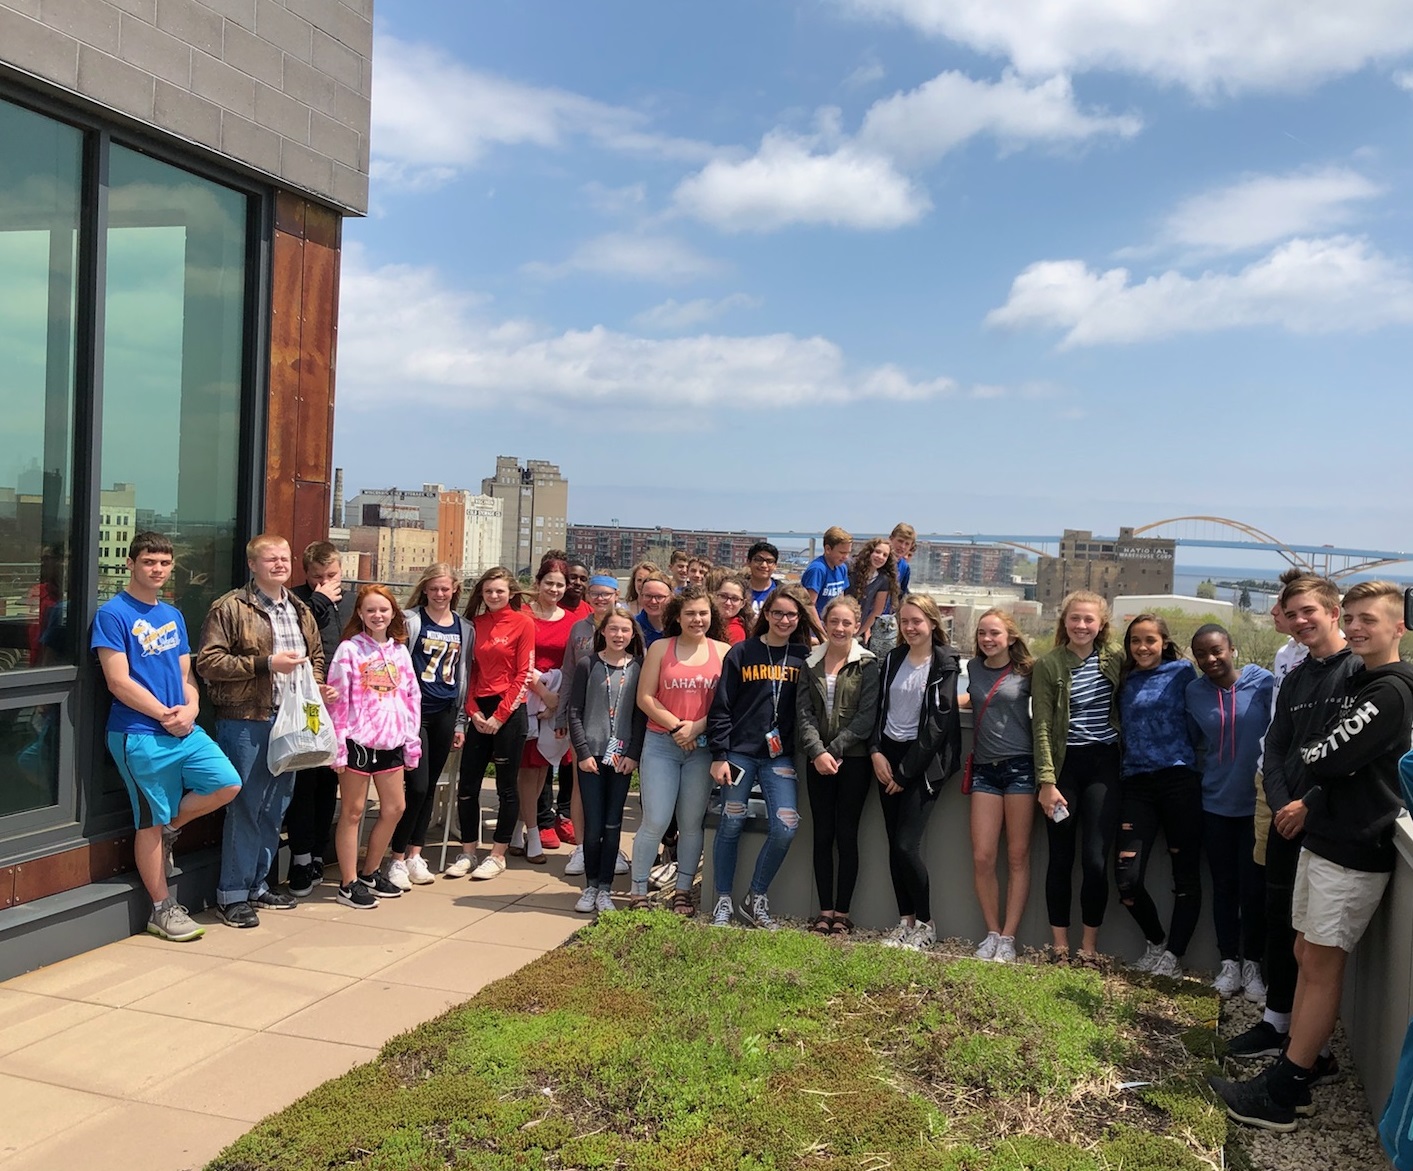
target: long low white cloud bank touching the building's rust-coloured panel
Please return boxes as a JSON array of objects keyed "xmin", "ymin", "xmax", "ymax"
[{"xmin": 339, "ymin": 247, "xmax": 959, "ymax": 412}]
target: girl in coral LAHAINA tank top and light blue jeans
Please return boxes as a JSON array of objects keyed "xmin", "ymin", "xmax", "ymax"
[{"xmin": 629, "ymin": 586, "xmax": 731, "ymax": 917}]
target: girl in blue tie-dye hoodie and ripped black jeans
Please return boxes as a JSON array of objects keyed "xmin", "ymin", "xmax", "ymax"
[{"xmin": 1113, "ymin": 614, "xmax": 1202, "ymax": 977}]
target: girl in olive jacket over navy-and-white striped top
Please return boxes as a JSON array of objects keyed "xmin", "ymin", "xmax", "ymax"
[{"xmin": 1030, "ymin": 590, "xmax": 1123, "ymax": 965}]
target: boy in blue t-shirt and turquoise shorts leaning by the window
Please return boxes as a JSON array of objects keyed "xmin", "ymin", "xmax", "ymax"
[{"xmin": 92, "ymin": 533, "xmax": 240, "ymax": 942}]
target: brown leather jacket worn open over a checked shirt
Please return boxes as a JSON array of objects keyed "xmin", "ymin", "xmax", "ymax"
[{"xmin": 195, "ymin": 582, "xmax": 324, "ymax": 719}]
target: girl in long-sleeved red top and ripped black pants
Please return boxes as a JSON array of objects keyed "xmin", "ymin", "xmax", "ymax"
[{"xmin": 447, "ymin": 565, "xmax": 544, "ymax": 879}]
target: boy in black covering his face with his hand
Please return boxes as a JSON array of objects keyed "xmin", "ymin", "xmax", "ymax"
[{"xmin": 284, "ymin": 541, "xmax": 353, "ymax": 898}]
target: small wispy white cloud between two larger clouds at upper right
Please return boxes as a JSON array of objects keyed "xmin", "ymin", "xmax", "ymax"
[{"xmin": 1159, "ymin": 167, "xmax": 1383, "ymax": 253}]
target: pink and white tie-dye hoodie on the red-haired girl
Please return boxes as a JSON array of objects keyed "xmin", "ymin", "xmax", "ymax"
[{"xmin": 328, "ymin": 634, "xmax": 422, "ymax": 768}]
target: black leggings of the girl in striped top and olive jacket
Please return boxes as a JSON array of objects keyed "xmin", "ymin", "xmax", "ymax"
[{"xmin": 1046, "ymin": 744, "xmax": 1119, "ymax": 927}]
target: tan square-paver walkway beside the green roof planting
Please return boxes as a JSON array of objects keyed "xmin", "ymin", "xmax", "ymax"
[{"xmin": 0, "ymin": 848, "xmax": 590, "ymax": 1171}]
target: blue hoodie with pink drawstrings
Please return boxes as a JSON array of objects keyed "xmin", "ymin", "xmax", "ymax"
[{"xmin": 1187, "ymin": 662, "xmax": 1276, "ymax": 818}]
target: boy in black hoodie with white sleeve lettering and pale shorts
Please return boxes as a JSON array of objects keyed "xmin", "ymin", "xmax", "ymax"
[{"xmin": 1212, "ymin": 582, "xmax": 1413, "ymax": 1130}]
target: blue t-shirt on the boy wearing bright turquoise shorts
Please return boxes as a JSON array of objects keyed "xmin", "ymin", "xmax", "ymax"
[{"xmin": 90, "ymin": 589, "xmax": 191, "ymax": 736}]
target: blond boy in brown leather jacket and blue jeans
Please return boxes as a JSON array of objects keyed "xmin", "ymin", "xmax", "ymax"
[{"xmin": 196, "ymin": 533, "xmax": 324, "ymax": 927}]
